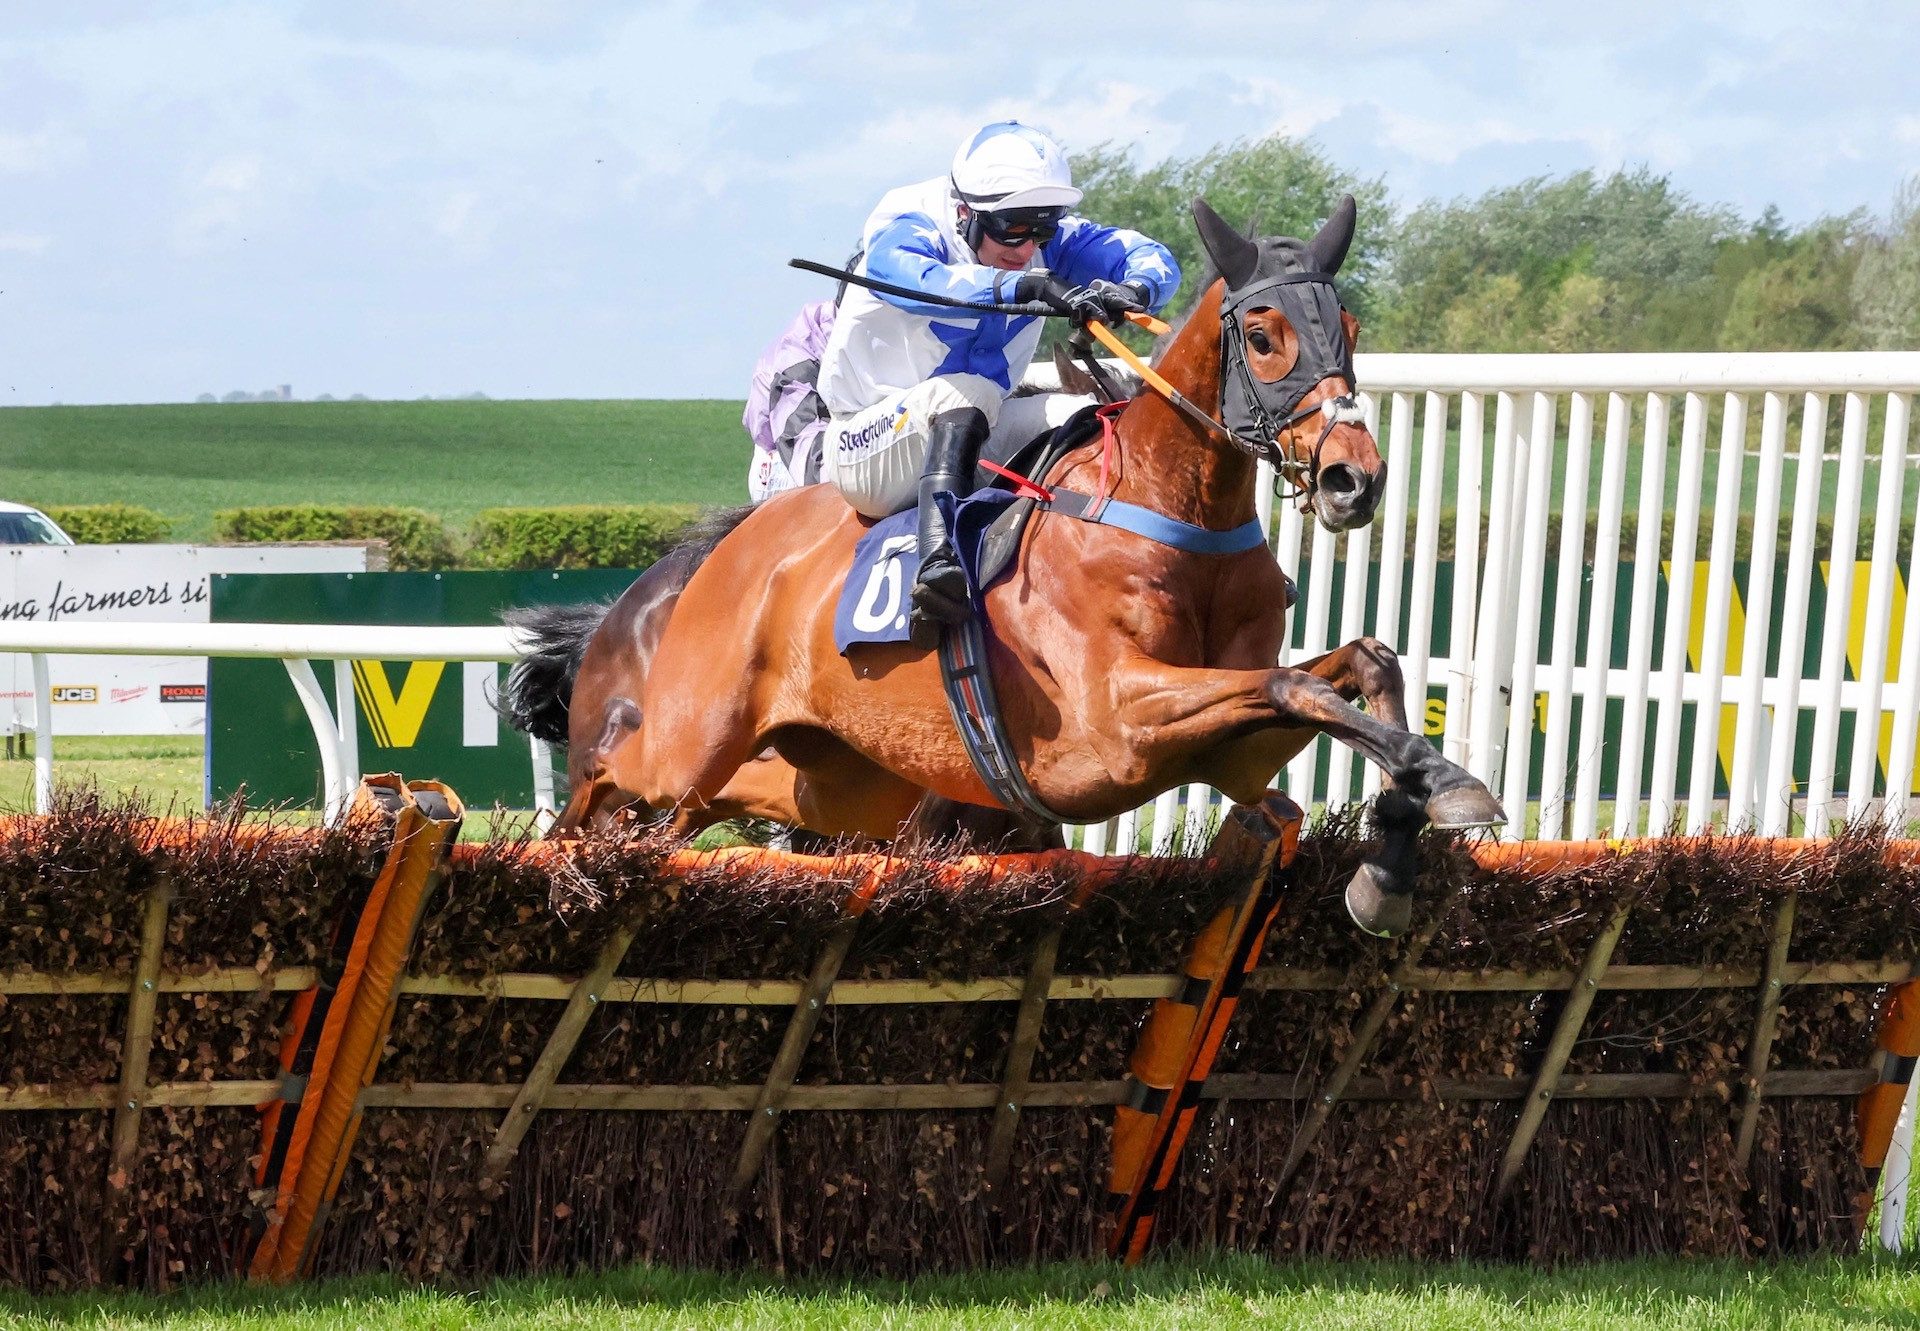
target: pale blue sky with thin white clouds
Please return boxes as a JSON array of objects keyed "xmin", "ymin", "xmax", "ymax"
[{"xmin": 0, "ymin": 0, "xmax": 1920, "ymax": 405}]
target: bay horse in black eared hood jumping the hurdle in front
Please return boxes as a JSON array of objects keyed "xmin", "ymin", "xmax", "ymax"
[{"xmin": 503, "ymin": 198, "xmax": 1503, "ymax": 933}]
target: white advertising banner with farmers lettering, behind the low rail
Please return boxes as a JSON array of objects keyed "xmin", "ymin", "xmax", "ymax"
[{"xmin": 0, "ymin": 545, "xmax": 367, "ymax": 736}]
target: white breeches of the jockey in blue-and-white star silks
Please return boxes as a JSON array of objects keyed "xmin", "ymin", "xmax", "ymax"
[{"xmin": 822, "ymin": 375, "xmax": 1092, "ymax": 517}]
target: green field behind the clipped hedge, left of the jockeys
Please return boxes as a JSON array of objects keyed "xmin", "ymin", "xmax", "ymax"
[{"xmin": 0, "ymin": 401, "xmax": 751, "ymax": 540}]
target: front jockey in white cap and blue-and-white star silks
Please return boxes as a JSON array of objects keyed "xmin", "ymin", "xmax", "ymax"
[{"xmin": 820, "ymin": 121, "xmax": 1181, "ymax": 647}]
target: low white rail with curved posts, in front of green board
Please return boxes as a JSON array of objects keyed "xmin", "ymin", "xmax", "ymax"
[{"xmin": 0, "ymin": 620, "xmax": 555, "ymax": 820}]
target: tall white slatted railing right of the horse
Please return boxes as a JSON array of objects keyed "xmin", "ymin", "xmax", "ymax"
[{"xmin": 1081, "ymin": 351, "xmax": 1920, "ymax": 851}]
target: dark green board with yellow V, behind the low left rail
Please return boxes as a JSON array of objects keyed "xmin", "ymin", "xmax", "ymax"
[{"xmin": 207, "ymin": 569, "xmax": 637, "ymax": 809}]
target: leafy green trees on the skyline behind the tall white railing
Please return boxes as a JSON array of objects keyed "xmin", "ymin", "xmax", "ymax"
[{"xmin": 1073, "ymin": 136, "xmax": 1920, "ymax": 351}]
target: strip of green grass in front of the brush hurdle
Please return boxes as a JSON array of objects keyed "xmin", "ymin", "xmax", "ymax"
[{"xmin": 0, "ymin": 1256, "xmax": 1920, "ymax": 1331}]
